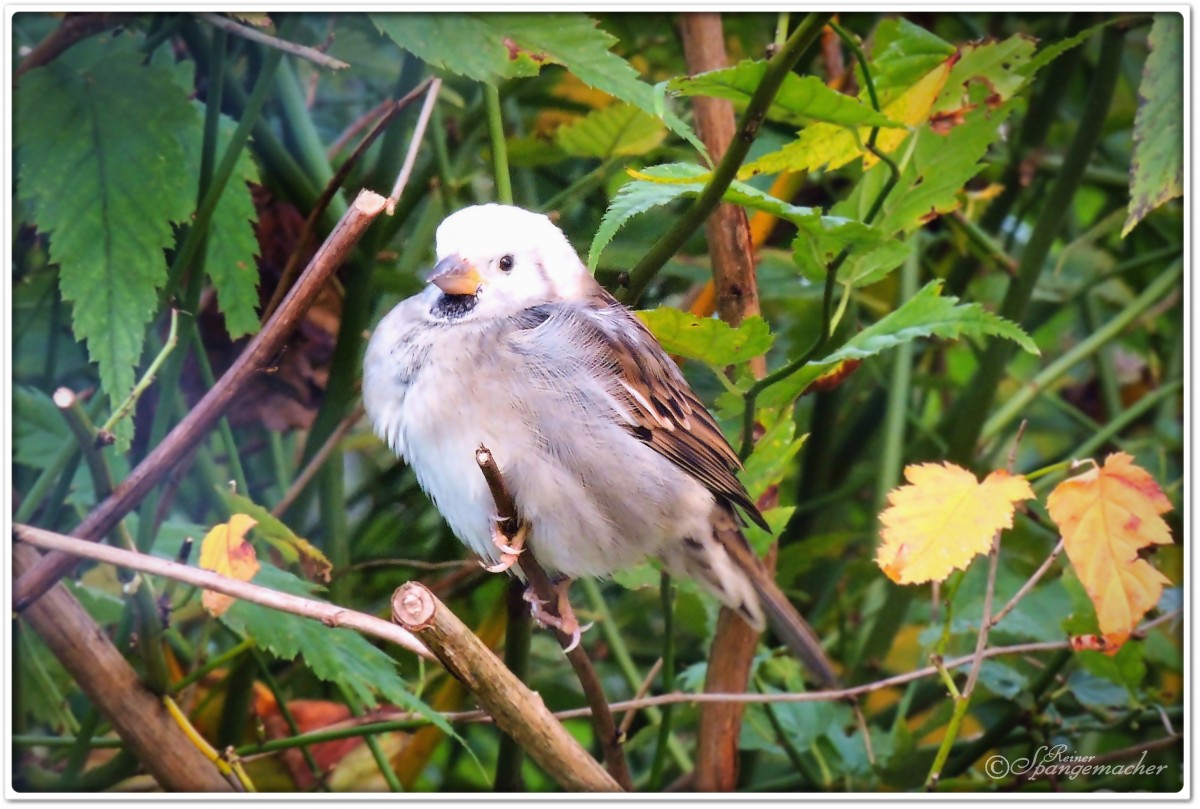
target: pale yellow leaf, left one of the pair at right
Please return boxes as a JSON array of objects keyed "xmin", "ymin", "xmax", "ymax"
[{"xmin": 875, "ymin": 463, "xmax": 1033, "ymax": 585}]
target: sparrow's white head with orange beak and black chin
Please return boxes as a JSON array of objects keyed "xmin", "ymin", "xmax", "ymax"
[{"xmin": 430, "ymin": 204, "xmax": 592, "ymax": 319}]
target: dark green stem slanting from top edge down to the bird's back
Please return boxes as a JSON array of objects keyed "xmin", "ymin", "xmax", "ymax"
[{"xmin": 618, "ymin": 13, "xmax": 833, "ymax": 306}]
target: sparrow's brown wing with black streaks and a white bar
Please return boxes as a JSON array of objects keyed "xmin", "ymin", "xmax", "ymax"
[{"xmin": 508, "ymin": 284, "xmax": 768, "ymax": 529}]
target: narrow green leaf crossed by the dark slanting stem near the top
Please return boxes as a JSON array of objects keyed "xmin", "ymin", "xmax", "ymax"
[{"xmin": 667, "ymin": 60, "xmax": 902, "ymax": 127}]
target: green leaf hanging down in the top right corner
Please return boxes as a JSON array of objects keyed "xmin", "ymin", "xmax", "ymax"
[{"xmin": 1121, "ymin": 11, "xmax": 1183, "ymax": 236}]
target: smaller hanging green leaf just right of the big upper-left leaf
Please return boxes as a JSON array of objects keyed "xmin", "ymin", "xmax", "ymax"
[{"xmin": 180, "ymin": 106, "xmax": 260, "ymax": 340}]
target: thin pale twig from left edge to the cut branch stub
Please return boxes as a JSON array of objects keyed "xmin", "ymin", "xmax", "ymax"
[{"xmin": 13, "ymin": 525, "xmax": 432, "ymax": 659}]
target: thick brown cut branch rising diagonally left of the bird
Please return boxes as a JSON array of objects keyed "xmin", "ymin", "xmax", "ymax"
[{"xmin": 13, "ymin": 191, "xmax": 385, "ymax": 612}]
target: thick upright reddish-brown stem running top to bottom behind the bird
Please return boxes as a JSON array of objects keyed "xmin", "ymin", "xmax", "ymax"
[{"xmin": 679, "ymin": 12, "xmax": 775, "ymax": 792}]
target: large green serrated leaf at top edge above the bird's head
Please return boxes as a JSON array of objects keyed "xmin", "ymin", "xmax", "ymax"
[{"xmin": 371, "ymin": 12, "xmax": 707, "ymax": 154}]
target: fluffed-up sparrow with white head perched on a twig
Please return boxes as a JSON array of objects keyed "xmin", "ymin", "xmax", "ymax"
[{"xmin": 362, "ymin": 203, "xmax": 836, "ymax": 684}]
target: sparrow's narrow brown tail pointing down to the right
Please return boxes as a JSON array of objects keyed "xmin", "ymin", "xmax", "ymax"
[{"xmin": 662, "ymin": 504, "xmax": 838, "ymax": 685}]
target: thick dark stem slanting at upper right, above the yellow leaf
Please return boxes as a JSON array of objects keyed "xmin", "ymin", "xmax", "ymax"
[{"xmin": 943, "ymin": 26, "xmax": 1124, "ymax": 463}]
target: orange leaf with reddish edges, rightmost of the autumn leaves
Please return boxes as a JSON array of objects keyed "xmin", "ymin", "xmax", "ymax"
[{"xmin": 1046, "ymin": 453, "xmax": 1171, "ymax": 646}]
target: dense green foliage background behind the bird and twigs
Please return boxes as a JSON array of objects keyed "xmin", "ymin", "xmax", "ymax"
[{"xmin": 12, "ymin": 12, "xmax": 1184, "ymax": 791}]
